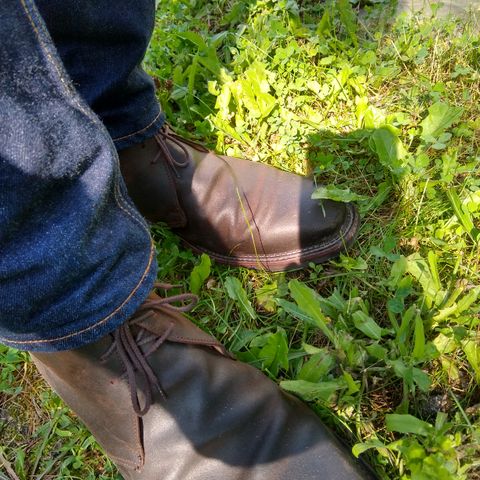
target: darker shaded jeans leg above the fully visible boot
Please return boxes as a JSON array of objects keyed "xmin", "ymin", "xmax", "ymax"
[{"xmin": 35, "ymin": 0, "xmax": 164, "ymax": 150}]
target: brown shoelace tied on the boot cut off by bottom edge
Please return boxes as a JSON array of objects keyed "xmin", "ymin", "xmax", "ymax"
[{"xmin": 100, "ymin": 283, "xmax": 198, "ymax": 417}]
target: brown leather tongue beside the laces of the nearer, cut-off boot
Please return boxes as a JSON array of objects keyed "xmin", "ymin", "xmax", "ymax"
[{"xmin": 137, "ymin": 307, "xmax": 232, "ymax": 358}]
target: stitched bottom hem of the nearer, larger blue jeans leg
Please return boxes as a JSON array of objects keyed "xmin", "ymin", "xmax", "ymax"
[{"xmin": 0, "ymin": 242, "xmax": 157, "ymax": 352}]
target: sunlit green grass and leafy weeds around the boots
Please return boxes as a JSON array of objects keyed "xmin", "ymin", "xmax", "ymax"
[{"xmin": 0, "ymin": 0, "xmax": 480, "ymax": 480}]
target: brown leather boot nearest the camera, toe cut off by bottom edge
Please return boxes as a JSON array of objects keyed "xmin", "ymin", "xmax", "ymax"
[{"xmin": 32, "ymin": 284, "xmax": 374, "ymax": 480}]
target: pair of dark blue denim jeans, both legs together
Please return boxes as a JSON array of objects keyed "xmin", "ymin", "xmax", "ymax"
[{"xmin": 0, "ymin": 0, "xmax": 163, "ymax": 351}]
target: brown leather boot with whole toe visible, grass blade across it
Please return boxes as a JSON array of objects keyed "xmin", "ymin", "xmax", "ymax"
[{"xmin": 119, "ymin": 126, "xmax": 359, "ymax": 271}]
